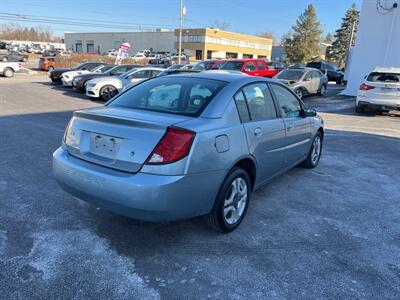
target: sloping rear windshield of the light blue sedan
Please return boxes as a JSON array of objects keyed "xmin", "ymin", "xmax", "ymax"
[{"xmin": 109, "ymin": 77, "xmax": 227, "ymax": 117}]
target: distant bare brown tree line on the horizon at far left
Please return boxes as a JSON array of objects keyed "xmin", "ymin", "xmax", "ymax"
[{"xmin": 0, "ymin": 24, "xmax": 61, "ymax": 42}]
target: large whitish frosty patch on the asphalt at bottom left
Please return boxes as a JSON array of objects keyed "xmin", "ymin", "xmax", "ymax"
[{"xmin": 29, "ymin": 230, "xmax": 159, "ymax": 299}]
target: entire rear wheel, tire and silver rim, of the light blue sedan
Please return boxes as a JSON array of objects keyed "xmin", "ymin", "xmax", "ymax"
[{"xmin": 204, "ymin": 168, "xmax": 251, "ymax": 232}]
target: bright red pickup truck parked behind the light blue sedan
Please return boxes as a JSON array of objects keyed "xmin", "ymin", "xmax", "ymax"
[{"xmin": 219, "ymin": 58, "xmax": 280, "ymax": 78}]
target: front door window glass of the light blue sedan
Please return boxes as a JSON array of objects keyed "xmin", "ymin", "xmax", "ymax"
[{"xmin": 271, "ymin": 84, "xmax": 302, "ymax": 118}]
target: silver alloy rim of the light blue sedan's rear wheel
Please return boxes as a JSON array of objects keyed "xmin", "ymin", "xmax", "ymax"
[{"xmin": 224, "ymin": 177, "xmax": 248, "ymax": 225}]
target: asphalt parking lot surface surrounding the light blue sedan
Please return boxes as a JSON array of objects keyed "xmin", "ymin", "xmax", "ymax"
[{"xmin": 0, "ymin": 76, "xmax": 400, "ymax": 299}]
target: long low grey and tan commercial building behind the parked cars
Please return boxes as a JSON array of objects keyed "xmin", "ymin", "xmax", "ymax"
[{"xmin": 65, "ymin": 28, "xmax": 272, "ymax": 61}]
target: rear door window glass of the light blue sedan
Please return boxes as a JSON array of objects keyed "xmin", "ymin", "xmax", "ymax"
[{"xmin": 243, "ymin": 82, "xmax": 277, "ymax": 121}]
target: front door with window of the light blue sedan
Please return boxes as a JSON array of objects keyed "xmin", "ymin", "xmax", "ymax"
[{"xmin": 270, "ymin": 83, "xmax": 311, "ymax": 167}]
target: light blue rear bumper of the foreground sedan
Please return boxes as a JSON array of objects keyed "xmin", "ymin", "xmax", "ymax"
[{"xmin": 53, "ymin": 148, "xmax": 225, "ymax": 221}]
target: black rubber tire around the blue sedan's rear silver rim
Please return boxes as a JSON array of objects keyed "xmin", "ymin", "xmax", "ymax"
[{"xmin": 204, "ymin": 167, "xmax": 251, "ymax": 233}]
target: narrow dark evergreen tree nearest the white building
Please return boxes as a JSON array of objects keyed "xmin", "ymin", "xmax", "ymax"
[{"xmin": 329, "ymin": 4, "xmax": 360, "ymax": 68}]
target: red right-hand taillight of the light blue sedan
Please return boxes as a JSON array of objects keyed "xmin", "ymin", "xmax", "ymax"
[{"xmin": 145, "ymin": 127, "xmax": 196, "ymax": 165}]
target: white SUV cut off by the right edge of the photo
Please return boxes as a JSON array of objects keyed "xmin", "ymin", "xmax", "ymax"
[{"xmin": 356, "ymin": 68, "xmax": 400, "ymax": 113}]
